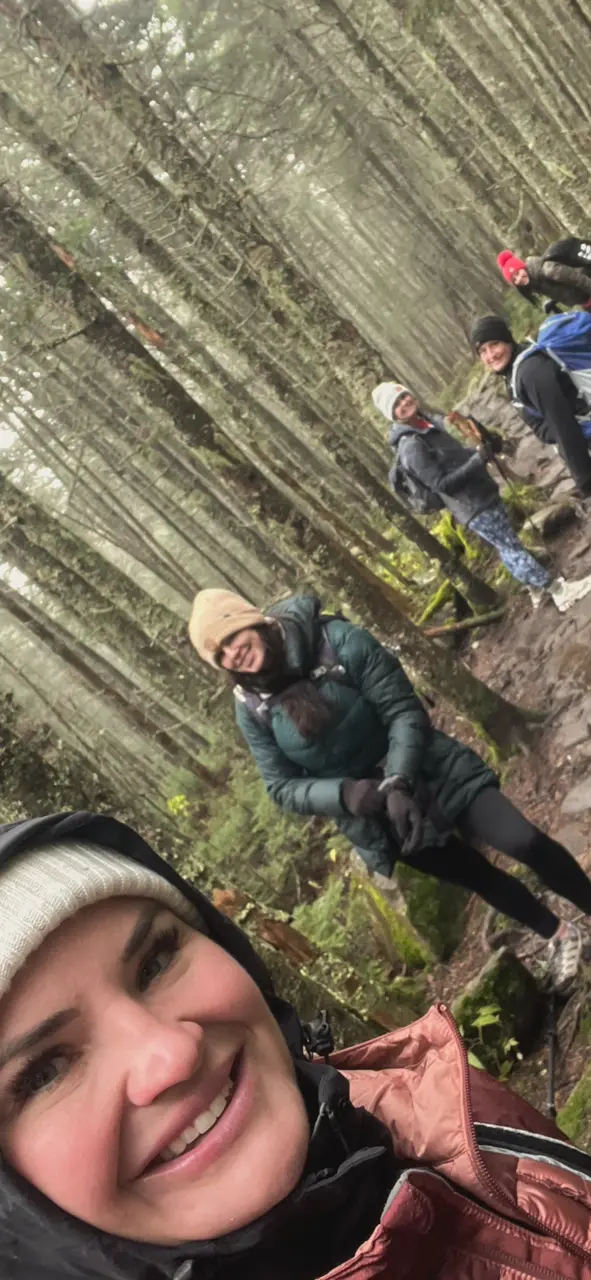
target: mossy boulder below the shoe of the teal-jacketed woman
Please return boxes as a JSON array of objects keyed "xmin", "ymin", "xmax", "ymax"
[{"xmin": 452, "ymin": 947, "xmax": 542, "ymax": 1076}]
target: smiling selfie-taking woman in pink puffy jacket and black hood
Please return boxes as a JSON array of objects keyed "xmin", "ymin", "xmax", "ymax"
[{"xmin": 0, "ymin": 813, "xmax": 591, "ymax": 1280}]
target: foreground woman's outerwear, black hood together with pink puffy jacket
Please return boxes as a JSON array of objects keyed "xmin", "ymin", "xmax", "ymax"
[{"xmin": 0, "ymin": 813, "xmax": 591, "ymax": 1280}]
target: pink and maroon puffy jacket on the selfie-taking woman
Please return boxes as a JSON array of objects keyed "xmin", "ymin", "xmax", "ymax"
[{"xmin": 324, "ymin": 1005, "xmax": 591, "ymax": 1280}]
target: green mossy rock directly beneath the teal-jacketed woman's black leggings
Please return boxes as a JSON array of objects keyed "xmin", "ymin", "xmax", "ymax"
[{"xmin": 395, "ymin": 861, "xmax": 469, "ymax": 960}]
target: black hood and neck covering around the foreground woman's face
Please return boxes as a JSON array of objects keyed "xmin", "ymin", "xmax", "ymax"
[{"xmin": 0, "ymin": 813, "xmax": 394, "ymax": 1280}]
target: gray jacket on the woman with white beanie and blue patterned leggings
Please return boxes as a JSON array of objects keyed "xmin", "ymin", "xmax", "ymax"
[{"xmin": 389, "ymin": 415, "xmax": 499, "ymax": 525}]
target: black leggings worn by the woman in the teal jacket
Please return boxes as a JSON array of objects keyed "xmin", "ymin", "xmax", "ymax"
[{"xmin": 408, "ymin": 787, "xmax": 591, "ymax": 938}]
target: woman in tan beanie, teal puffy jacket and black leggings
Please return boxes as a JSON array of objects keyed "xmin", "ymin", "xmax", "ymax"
[{"xmin": 189, "ymin": 589, "xmax": 591, "ymax": 982}]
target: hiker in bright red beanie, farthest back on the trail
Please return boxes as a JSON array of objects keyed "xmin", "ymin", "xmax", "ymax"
[{"xmin": 496, "ymin": 245, "xmax": 591, "ymax": 311}]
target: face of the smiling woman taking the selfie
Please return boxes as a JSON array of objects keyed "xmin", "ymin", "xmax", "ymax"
[{"xmin": 0, "ymin": 897, "xmax": 308, "ymax": 1244}]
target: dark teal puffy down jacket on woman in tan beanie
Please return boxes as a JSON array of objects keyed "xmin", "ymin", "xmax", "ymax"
[{"xmin": 235, "ymin": 595, "xmax": 498, "ymax": 876}]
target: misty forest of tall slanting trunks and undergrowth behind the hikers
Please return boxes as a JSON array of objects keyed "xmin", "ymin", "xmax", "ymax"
[{"xmin": 0, "ymin": 0, "xmax": 591, "ymax": 1025}]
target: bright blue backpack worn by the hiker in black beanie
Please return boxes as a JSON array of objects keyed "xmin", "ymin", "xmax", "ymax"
[{"xmin": 510, "ymin": 311, "xmax": 591, "ymax": 440}]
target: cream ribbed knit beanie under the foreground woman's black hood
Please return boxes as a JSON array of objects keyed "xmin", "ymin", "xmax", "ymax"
[{"xmin": 0, "ymin": 841, "xmax": 205, "ymax": 997}]
